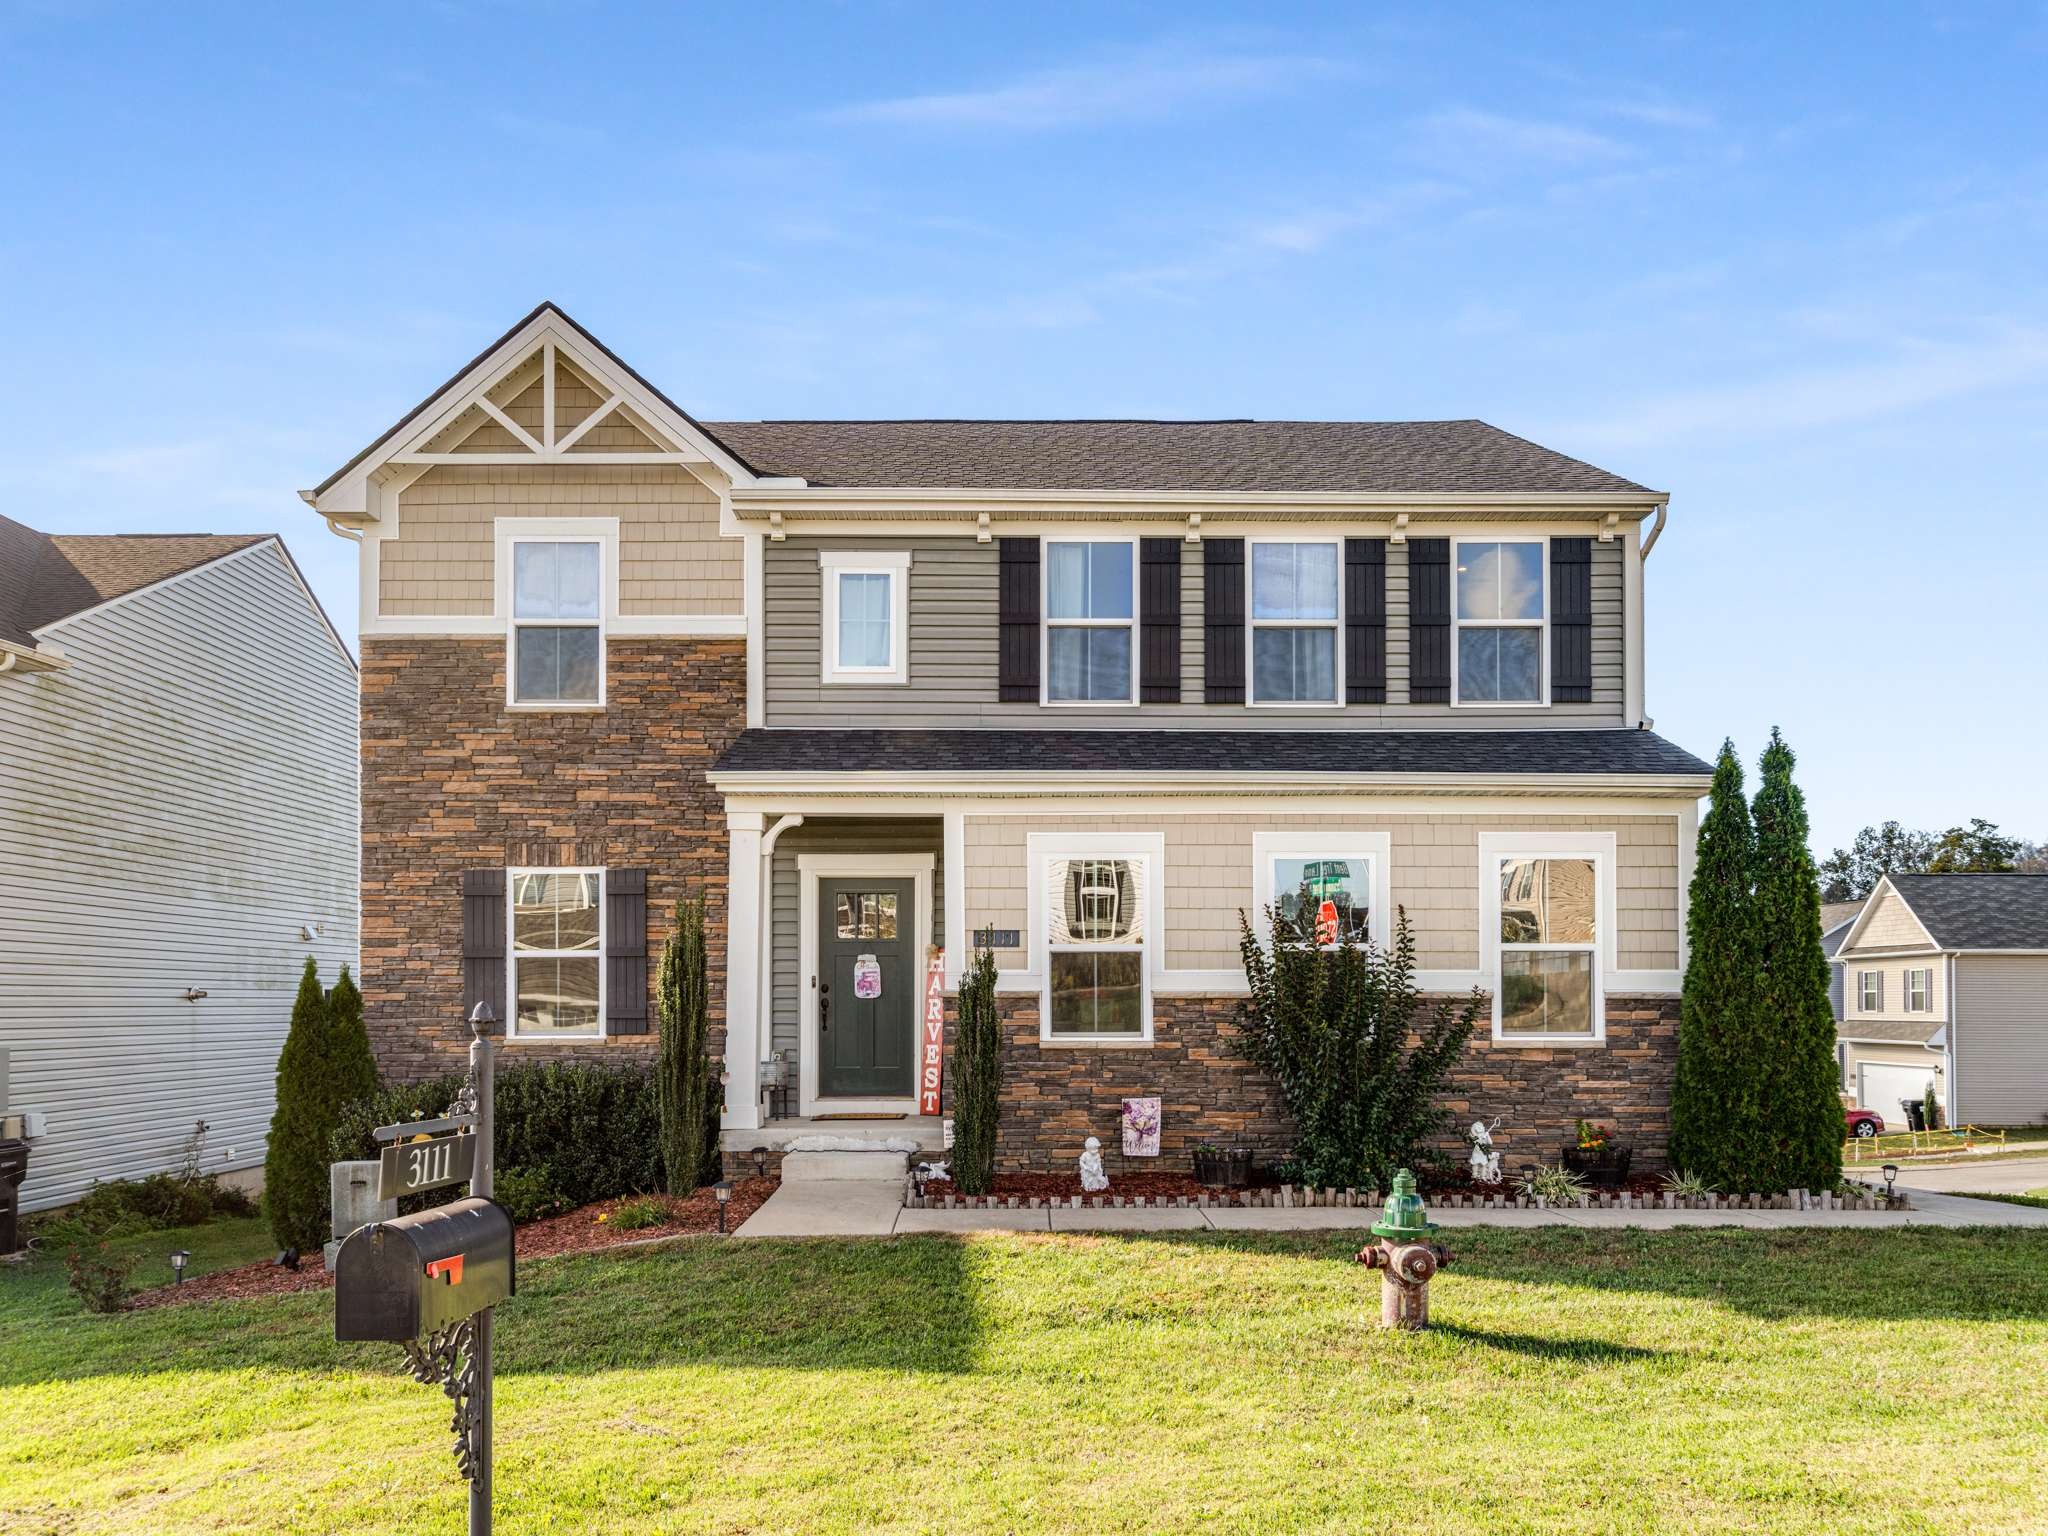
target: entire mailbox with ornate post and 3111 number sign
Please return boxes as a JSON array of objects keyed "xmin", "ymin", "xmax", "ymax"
[{"xmin": 334, "ymin": 1004, "xmax": 516, "ymax": 1536}]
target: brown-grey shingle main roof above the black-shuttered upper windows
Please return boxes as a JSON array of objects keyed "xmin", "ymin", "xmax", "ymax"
[{"xmin": 705, "ymin": 420, "xmax": 1645, "ymax": 494}]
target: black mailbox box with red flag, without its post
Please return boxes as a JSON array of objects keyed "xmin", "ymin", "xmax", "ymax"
[{"xmin": 334, "ymin": 1200, "xmax": 512, "ymax": 1343}]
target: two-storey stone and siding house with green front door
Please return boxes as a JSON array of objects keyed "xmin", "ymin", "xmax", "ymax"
[{"xmin": 305, "ymin": 305, "xmax": 1710, "ymax": 1167}]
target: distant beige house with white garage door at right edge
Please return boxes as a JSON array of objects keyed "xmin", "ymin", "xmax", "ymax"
[{"xmin": 1835, "ymin": 874, "xmax": 2048, "ymax": 1126}]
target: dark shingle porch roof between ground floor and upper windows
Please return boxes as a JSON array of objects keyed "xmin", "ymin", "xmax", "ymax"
[{"xmin": 713, "ymin": 729, "xmax": 1714, "ymax": 778}]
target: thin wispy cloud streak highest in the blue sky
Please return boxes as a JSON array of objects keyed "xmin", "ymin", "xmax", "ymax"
[{"xmin": 827, "ymin": 43, "xmax": 1339, "ymax": 131}]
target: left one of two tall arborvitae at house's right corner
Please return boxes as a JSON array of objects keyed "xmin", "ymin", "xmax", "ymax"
[{"xmin": 1671, "ymin": 741, "xmax": 1761, "ymax": 1194}]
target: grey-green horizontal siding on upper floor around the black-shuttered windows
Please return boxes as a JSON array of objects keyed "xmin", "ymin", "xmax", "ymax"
[{"xmin": 761, "ymin": 524, "xmax": 1626, "ymax": 731}]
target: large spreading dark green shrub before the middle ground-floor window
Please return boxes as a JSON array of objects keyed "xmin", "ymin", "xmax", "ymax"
[{"xmin": 1237, "ymin": 911, "xmax": 1481, "ymax": 1190}]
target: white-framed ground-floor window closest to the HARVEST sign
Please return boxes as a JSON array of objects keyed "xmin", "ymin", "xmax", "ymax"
[{"xmin": 1042, "ymin": 854, "xmax": 1151, "ymax": 1040}]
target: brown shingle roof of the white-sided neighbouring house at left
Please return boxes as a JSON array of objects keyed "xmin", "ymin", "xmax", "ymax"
[{"xmin": 0, "ymin": 516, "xmax": 274, "ymax": 645}]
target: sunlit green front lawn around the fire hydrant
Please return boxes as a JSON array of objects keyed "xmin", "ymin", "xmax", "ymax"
[{"xmin": 0, "ymin": 1229, "xmax": 2048, "ymax": 1536}]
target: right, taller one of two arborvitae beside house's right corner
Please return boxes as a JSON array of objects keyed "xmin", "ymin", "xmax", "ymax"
[{"xmin": 1747, "ymin": 729, "xmax": 1841, "ymax": 1194}]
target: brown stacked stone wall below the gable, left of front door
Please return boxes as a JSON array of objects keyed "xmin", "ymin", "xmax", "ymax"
[{"xmin": 360, "ymin": 637, "xmax": 745, "ymax": 1079}]
